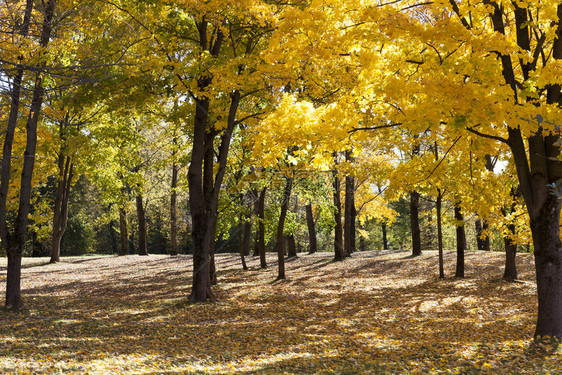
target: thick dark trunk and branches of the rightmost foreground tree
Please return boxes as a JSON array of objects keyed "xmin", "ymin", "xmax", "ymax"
[{"xmin": 462, "ymin": 2, "xmax": 562, "ymax": 338}]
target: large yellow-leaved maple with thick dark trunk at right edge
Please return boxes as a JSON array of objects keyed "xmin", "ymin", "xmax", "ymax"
[{"xmin": 376, "ymin": 1, "xmax": 562, "ymax": 337}]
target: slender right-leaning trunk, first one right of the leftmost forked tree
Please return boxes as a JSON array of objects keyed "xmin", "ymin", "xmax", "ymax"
[{"xmin": 50, "ymin": 154, "xmax": 74, "ymax": 263}]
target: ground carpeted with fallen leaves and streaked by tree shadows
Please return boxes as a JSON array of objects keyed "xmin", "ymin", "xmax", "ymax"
[{"xmin": 0, "ymin": 251, "xmax": 562, "ymax": 374}]
